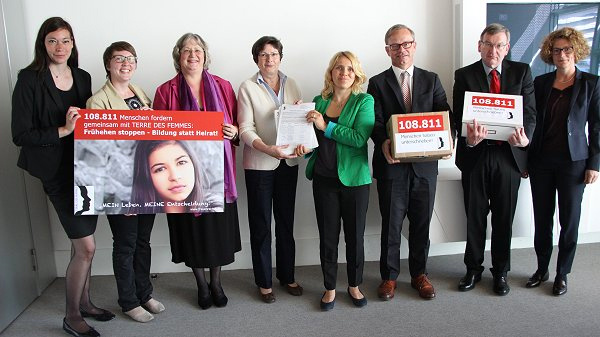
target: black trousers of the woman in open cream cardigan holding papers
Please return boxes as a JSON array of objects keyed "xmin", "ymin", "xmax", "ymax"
[{"xmin": 245, "ymin": 160, "xmax": 298, "ymax": 289}]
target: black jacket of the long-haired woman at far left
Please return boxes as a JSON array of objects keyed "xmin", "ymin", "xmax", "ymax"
[{"xmin": 11, "ymin": 68, "xmax": 92, "ymax": 181}]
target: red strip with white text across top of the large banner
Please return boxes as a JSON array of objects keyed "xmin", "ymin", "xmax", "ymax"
[{"xmin": 74, "ymin": 109, "xmax": 223, "ymax": 140}]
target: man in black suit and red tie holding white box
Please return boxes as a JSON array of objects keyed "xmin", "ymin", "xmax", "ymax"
[{"xmin": 452, "ymin": 23, "xmax": 535, "ymax": 296}]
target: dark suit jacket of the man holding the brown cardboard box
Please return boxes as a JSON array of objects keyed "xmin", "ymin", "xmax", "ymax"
[{"xmin": 367, "ymin": 67, "xmax": 455, "ymax": 179}]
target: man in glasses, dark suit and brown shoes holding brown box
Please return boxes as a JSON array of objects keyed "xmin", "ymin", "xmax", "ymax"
[{"xmin": 367, "ymin": 24, "xmax": 454, "ymax": 300}]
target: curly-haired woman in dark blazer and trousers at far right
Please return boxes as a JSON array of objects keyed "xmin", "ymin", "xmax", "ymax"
[{"xmin": 526, "ymin": 27, "xmax": 600, "ymax": 295}]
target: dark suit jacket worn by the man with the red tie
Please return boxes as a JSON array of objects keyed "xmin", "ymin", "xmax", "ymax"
[{"xmin": 452, "ymin": 60, "xmax": 535, "ymax": 172}]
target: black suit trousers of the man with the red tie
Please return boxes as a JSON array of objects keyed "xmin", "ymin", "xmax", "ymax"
[{"xmin": 462, "ymin": 143, "xmax": 521, "ymax": 275}]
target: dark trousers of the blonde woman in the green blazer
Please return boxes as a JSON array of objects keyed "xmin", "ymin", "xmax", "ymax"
[{"xmin": 313, "ymin": 175, "xmax": 369, "ymax": 290}]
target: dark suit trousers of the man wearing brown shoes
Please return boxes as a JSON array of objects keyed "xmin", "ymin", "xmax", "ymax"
[{"xmin": 377, "ymin": 164, "xmax": 437, "ymax": 280}]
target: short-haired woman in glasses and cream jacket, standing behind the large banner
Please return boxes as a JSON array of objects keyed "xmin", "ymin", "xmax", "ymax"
[{"xmin": 86, "ymin": 41, "xmax": 165, "ymax": 322}]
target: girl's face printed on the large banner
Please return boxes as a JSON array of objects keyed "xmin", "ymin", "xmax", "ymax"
[{"xmin": 148, "ymin": 143, "xmax": 196, "ymax": 201}]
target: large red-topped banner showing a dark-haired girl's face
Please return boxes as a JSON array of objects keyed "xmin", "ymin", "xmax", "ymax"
[{"xmin": 73, "ymin": 109, "xmax": 229, "ymax": 215}]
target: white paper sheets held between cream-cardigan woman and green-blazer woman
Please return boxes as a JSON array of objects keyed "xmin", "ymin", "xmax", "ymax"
[{"xmin": 275, "ymin": 102, "xmax": 319, "ymax": 154}]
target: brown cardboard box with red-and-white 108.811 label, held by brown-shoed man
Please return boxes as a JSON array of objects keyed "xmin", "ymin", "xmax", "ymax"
[{"xmin": 387, "ymin": 111, "xmax": 452, "ymax": 162}]
